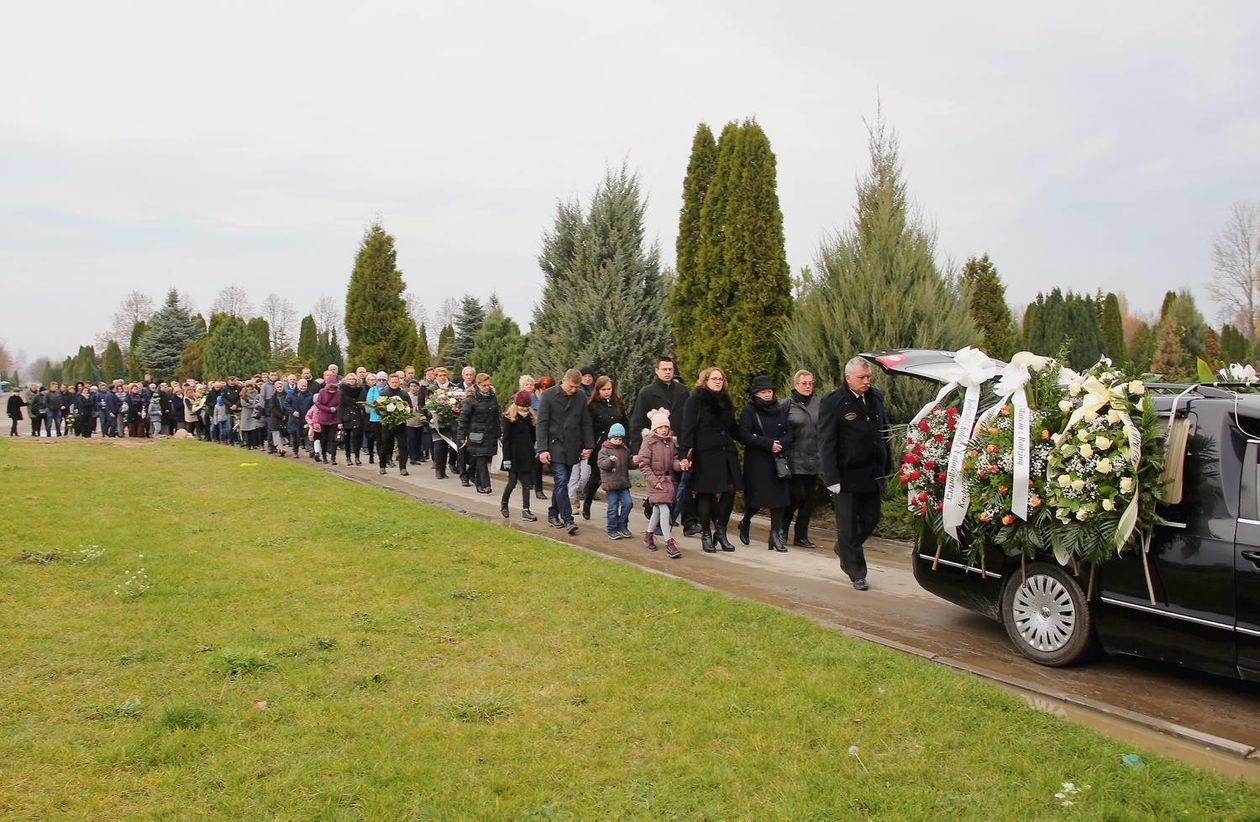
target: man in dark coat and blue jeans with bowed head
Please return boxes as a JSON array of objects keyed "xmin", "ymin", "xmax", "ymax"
[{"xmin": 534, "ymin": 368, "xmax": 595, "ymax": 535}]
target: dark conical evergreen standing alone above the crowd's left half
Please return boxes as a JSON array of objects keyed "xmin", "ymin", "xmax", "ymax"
[{"xmin": 345, "ymin": 223, "xmax": 416, "ymax": 371}]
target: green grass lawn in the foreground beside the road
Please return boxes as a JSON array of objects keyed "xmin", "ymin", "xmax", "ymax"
[{"xmin": 0, "ymin": 440, "xmax": 1260, "ymax": 818}]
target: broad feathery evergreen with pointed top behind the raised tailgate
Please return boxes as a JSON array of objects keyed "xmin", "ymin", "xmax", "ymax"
[{"xmin": 781, "ymin": 112, "xmax": 979, "ymax": 422}]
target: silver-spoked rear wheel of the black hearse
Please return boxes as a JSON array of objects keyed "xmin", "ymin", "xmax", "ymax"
[{"xmin": 1002, "ymin": 562, "xmax": 1094, "ymax": 667}]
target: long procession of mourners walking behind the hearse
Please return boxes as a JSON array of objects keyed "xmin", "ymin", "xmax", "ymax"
[{"xmin": 8, "ymin": 357, "xmax": 892, "ymax": 590}]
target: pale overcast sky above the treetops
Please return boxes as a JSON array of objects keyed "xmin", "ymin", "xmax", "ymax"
[{"xmin": 0, "ymin": 0, "xmax": 1260, "ymax": 359}]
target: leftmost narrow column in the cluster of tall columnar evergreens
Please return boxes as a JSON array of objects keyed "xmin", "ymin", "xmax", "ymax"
[{"xmin": 663, "ymin": 122, "xmax": 732, "ymax": 374}]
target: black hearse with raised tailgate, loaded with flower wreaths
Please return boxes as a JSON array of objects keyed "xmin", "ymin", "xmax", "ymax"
[{"xmin": 863, "ymin": 349, "xmax": 1260, "ymax": 681}]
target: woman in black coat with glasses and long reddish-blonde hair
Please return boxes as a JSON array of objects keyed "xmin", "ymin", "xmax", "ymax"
[{"xmin": 678, "ymin": 368, "xmax": 743, "ymax": 553}]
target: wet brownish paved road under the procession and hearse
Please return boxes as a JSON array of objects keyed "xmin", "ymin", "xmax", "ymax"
[{"xmin": 309, "ymin": 465, "xmax": 1260, "ymax": 782}]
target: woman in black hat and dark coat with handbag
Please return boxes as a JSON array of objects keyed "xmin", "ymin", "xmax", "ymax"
[{"xmin": 740, "ymin": 376, "xmax": 791, "ymax": 553}]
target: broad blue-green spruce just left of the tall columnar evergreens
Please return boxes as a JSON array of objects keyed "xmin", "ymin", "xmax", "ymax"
[{"xmin": 526, "ymin": 166, "xmax": 669, "ymax": 397}]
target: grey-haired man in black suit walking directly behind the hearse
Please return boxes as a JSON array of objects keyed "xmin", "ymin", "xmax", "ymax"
[{"xmin": 818, "ymin": 357, "xmax": 892, "ymax": 591}]
